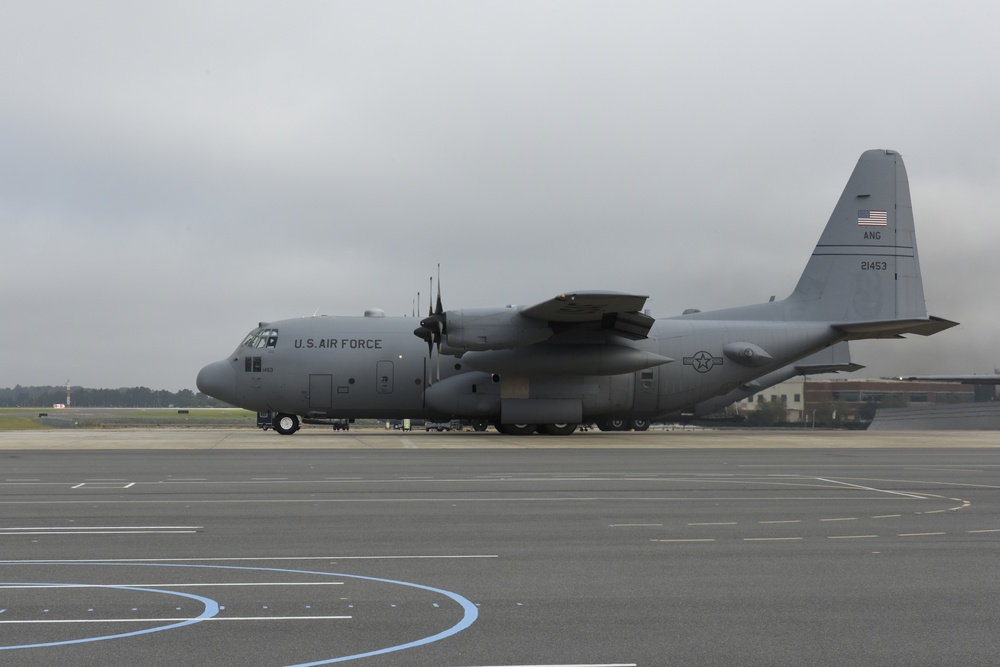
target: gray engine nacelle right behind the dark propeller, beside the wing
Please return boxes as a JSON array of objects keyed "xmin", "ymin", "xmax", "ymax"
[{"xmin": 445, "ymin": 307, "xmax": 553, "ymax": 350}]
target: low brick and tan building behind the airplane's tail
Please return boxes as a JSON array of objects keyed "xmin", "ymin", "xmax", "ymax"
[{"xmin": 734, "ymin": 377, "xmax": 997, "ymax": 426}]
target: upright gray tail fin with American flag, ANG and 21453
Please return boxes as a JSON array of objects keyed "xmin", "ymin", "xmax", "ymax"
[{"xmin": 785, "ymin": 150, "xmax": 940, "ymax": 337}]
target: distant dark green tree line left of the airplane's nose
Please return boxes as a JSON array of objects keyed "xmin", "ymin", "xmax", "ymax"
[{"xmin": 0, "ymin": 385, "xmax": 228, "ymax": 408}]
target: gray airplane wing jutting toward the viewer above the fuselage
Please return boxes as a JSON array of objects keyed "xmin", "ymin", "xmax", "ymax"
[{"xmin": 520, "ymin": 291, "xmax": 654, "ymax": 339}]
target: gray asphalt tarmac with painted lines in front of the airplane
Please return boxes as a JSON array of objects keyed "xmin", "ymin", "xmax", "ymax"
[{"xmin": 0, "ymin": 429, "xmax": 1000, "ymax": 667}]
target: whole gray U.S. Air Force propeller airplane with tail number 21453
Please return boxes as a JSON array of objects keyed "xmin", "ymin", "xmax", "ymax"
[{"xmin": 198, "ymin": 150, "xmax": 956, "ymax": 435}]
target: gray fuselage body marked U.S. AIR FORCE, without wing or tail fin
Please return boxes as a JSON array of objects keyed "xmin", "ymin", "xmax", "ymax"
[{"xmin": 199, "ymin": 316, "xmax": 842, "ymax": 422}]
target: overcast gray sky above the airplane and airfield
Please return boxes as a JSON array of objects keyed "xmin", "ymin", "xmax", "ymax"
[{"xmin": 0, "ymin": 0, "xmax": 1000, "ymax": 391}]
